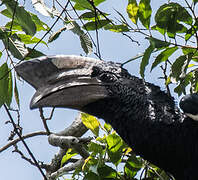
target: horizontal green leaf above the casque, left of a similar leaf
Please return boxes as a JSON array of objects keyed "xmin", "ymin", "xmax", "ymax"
[{"xmin": 83, "ymin": 20, "xmax": 110, "ymax": 31}]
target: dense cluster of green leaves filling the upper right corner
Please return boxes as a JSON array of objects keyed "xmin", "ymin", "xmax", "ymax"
[{"xmin": 127, "ymin": 0, "xmax": 198, "ymax": 95}]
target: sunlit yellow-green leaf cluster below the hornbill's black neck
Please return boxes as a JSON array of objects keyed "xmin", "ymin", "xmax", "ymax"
[{"xmin": 61, "ymin": 113, "xmax": 168, "ymax": 180}]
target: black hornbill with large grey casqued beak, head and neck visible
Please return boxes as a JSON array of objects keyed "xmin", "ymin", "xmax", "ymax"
[{"xmin": 16, "ymin": 55, "xmax": 198, "ymax": 180}]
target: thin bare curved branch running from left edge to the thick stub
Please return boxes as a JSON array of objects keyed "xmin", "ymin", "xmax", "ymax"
[{"xmin": 0, "ymin": 131, "xmax": 48, "ymax": 153}]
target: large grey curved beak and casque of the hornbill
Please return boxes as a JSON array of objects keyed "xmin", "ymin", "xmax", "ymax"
[{"xmin": 16, "ymin": 55, "xmax": 108, "ymax": 110}]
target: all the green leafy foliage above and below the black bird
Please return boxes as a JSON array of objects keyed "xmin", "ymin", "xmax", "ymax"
[{"xmin": 0, "ymin": 0, "xmax": 198, "ymax": 179}]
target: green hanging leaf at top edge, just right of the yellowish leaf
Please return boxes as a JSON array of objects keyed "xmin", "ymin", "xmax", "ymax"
[{"xmin": 138, "ymin": 0, "xmax": 152, "ymax": 29}]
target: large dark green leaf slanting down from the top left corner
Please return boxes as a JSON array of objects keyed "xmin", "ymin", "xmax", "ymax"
[{"xmin": 2, "ymin": 0, "xmax": 36, "ymax": 36}]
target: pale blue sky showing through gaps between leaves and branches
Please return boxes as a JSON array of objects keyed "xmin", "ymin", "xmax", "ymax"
[{"xmin": 0, "ymin": 0, "xmax": 184, "ymax": 180}]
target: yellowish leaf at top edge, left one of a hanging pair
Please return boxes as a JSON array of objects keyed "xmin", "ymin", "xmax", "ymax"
[{"xmin": 127, "ymin": 0, "xmax": 139, "ymax": 24}]
